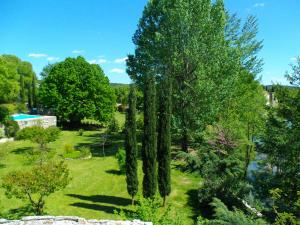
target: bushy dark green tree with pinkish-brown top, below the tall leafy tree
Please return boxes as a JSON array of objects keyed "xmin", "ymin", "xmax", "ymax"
[{"xmin": 198, "ymin": 126, "xmax": 250, "ymax": 205}]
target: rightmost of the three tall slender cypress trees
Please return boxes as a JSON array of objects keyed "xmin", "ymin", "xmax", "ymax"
[{"xmin": 157, "ymin": 77, "xmax": 172, "ymax": 206}]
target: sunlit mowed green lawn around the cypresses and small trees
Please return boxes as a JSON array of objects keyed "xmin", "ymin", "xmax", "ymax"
[{"xmin": 0, "ymin": 114, "xmax": 199, "ymax": 224}]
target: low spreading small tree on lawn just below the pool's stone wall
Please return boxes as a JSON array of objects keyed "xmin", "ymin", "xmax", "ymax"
[{"xmin": 17, "ymin": 126, "xmax": 60, "ymax": 150}]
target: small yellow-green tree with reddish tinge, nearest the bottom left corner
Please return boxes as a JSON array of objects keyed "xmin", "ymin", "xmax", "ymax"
[{"xmin": 2, "ymin": 162, "xmax": 70, "ymax": 215}]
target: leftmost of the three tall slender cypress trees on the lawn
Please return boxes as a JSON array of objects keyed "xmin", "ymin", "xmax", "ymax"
[{"xmin": 125, "ymin": 85, "xmax": 138, "ymax": 205}]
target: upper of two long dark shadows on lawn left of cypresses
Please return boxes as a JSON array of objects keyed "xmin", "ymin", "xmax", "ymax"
[{"xmin": 67, "ymin": 194, "xmax": 131, "ymax": 206}]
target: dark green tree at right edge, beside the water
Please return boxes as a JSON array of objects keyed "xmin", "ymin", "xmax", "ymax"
[{"xmin": 254, "ymin": 87, "xmax": 300, "ymax": 216}]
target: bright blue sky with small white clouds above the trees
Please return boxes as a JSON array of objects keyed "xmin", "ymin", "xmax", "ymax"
[{"xmin": 0, "ymin": 0, "xmax": 300, "ymax": 84}]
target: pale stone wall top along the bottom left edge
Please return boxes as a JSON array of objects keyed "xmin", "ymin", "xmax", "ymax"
[{"xmin": 0, "ymin": 216, "xmax": 153, "ymax": 225}]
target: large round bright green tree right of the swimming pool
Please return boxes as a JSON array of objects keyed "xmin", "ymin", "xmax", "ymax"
[{"xmin": 39, "ymin": 57, "xmax": 115, "ymax": 126}]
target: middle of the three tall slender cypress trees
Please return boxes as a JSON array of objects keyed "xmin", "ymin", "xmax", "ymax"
[{"xmin": 142, "ymin": 75, "xmax": 157, "ymax": 198}]
